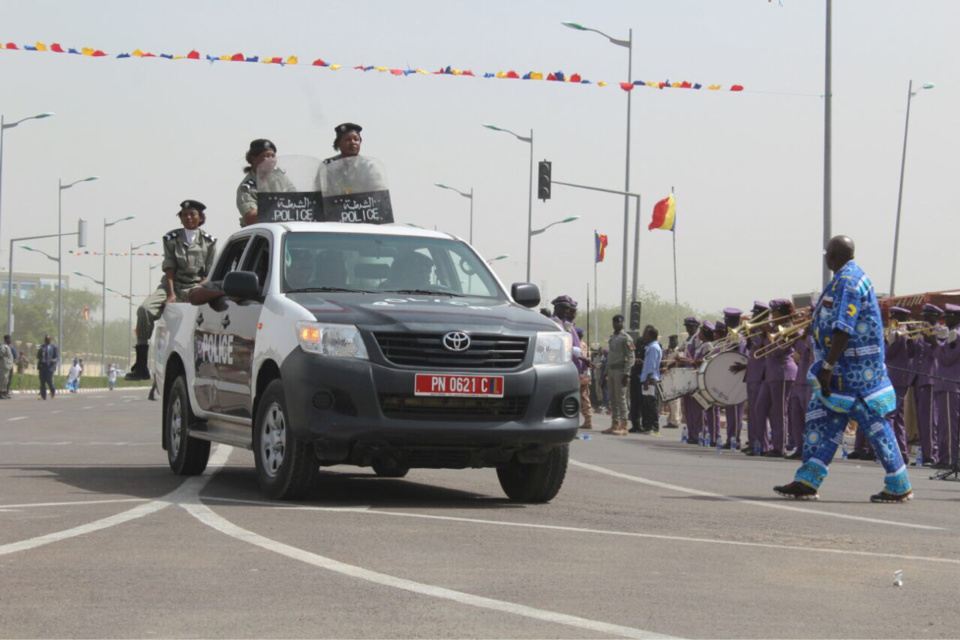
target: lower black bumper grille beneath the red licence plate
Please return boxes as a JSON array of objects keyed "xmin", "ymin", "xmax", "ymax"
[{"xmin": 380, "ymin": 394, "xmax": 528, "ymax": 422}]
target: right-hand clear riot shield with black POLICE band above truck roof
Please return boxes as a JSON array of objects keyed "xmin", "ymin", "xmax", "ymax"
[{"xmin": 317, "ymin": 156, "xmax": 393, "ymax": 224}]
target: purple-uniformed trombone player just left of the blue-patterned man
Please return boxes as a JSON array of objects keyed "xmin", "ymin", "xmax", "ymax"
[{"xmin": 757, "ymin": 298, "xmax": 797, "ymax": 458}]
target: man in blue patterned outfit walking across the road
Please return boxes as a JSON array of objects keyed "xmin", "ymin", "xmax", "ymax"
[{"xmin": 774, "ymin": 236, "xmax": 913, "ymax": 502}]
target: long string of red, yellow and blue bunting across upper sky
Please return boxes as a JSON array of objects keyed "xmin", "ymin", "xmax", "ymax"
[{"xmin": 0, "ymin": 41, "xmax": 743, "ymax": 91}]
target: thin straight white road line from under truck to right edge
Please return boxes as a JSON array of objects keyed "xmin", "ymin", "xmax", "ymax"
[{"xmin": 201, "ymin": 496, "xmax": 960, "ymax": 565}]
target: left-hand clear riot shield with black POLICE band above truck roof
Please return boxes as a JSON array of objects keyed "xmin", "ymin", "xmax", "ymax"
[{"xmin": 256, "ymin": 156, "xmax": 323, "ymax": 222}]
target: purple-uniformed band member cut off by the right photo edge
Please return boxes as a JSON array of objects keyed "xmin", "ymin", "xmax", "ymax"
[{"xmin": 934, "ymin": 304, "xmax": 960, "ymax": 469}]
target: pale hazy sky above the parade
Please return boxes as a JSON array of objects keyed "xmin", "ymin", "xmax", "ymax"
[{"xmin": 0, "ymin": 0, "xmax": 960, "ymax": 324}]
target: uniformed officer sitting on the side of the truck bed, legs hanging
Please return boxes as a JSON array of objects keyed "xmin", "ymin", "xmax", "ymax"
[{"xmin": 125, "ymin": 200, "xmax": 217, "ymax": 380}]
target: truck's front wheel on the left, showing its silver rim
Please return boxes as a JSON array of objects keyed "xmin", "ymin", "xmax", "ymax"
[{"xmin": 253, "ymin": 380, "xmax": 320, "ymax": 500}]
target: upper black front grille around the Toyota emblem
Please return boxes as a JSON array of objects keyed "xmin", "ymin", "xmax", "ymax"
[{"xmin": 373, "ymin": 333, "xmax": 528, "ymax": 369}]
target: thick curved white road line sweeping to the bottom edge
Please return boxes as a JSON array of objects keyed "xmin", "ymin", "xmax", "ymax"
[{"xmin": 181, "ymin": 502, "xmax": 669, "ymax": 638}]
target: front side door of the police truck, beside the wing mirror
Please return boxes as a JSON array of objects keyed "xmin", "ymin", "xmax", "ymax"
[{"xmin": 216, "ymin": 234, "xmax": 270, "ymax": 418}]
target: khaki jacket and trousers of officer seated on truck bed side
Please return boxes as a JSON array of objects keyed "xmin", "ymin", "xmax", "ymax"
[{"xmin": 137, "ymin": 228, "xmax": 217, "ymax": 345}]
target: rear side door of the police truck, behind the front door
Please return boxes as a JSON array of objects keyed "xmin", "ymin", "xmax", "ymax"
[{"xmin": 193, "ymin": 236, "xmax": 250, "ymax": 412}]
